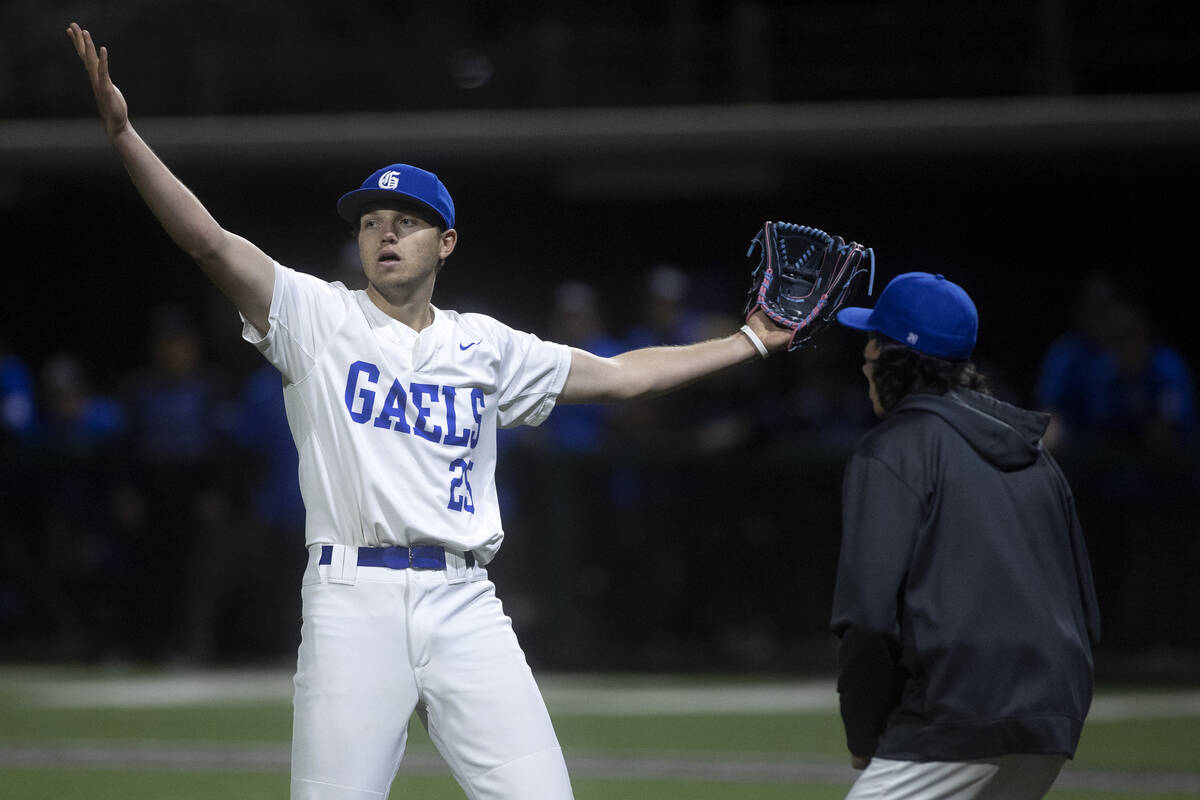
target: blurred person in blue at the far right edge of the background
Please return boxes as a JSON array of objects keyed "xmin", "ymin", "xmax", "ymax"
[{"xmin": 1080, "ymin": 299, "xmax": 1200, "ymax": 648}]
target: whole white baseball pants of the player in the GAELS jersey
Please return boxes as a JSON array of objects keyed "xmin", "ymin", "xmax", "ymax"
[{"xmin": 292, "ymin": 546, "xmax": 572, "ymax": 800}]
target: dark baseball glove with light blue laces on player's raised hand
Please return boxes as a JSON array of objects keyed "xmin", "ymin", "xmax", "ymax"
[{"xmin": 745, "ymin": 222, "xmax": 875, "ymax": 350}]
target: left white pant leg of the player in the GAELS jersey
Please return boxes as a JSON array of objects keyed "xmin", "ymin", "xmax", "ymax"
[{"xmin": 292, "ymin": 581, "xmax": 416, "ymax": 800}]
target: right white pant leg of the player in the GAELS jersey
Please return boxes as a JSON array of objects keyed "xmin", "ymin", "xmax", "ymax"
[{"xmin": 416, "ymin": 581, "xmax": 574, "ymax": 800}]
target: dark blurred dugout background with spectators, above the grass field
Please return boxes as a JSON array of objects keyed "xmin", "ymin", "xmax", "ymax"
[{"xmin": 0, "ymin": 0, "xmax": 1200, "ymax": 678}]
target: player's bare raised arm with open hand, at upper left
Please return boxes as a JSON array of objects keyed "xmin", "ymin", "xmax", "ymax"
[{"xmin": 67, "ymin": 23, "xmax": 275, "ymax": 331}]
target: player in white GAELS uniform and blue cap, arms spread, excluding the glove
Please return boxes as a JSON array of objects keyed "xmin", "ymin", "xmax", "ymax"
[{"xmin": 67, "ymin": 23, "xmax": 791, "ymax": 800}]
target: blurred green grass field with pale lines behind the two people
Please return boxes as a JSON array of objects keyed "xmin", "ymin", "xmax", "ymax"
[{"xmin": 0, "ymin": 668, "xmax": 1200, "ymax": 800}]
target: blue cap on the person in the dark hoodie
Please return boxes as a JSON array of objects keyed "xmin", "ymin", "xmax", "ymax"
[{"xmin": 838, "ymin": 272, "xmax": 979, "ymax": 360}]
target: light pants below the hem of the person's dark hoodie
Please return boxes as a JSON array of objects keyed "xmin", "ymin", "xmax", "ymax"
[{"xmin": 846, "ymin": 753, "xmax": 1067, "ymax": 800}]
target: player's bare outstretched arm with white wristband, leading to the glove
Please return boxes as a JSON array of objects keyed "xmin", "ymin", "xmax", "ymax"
[{"xmin": 558, "ymin": 311, "xmax": 792, "ymax": 404}]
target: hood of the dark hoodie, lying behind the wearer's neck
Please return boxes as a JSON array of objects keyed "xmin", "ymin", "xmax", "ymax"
[{"xmin": 892, "ymin": 390, "xmax": 1050, "ymax": 470}]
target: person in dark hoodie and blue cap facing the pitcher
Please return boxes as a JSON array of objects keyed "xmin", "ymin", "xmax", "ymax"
[{"xmin": 832, "ymin": 272, "xmax": 1100, "ymax": 800}]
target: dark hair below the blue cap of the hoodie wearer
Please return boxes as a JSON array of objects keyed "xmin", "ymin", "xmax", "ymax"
[{"xmin": 870, "ymin": 331, "xmax": 991, "ymax": 414}]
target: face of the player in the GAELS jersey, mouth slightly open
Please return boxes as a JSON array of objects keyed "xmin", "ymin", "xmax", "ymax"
[{"xmin": 359, "ymin": 205, "xmax": 457, "ymax": 300}]
